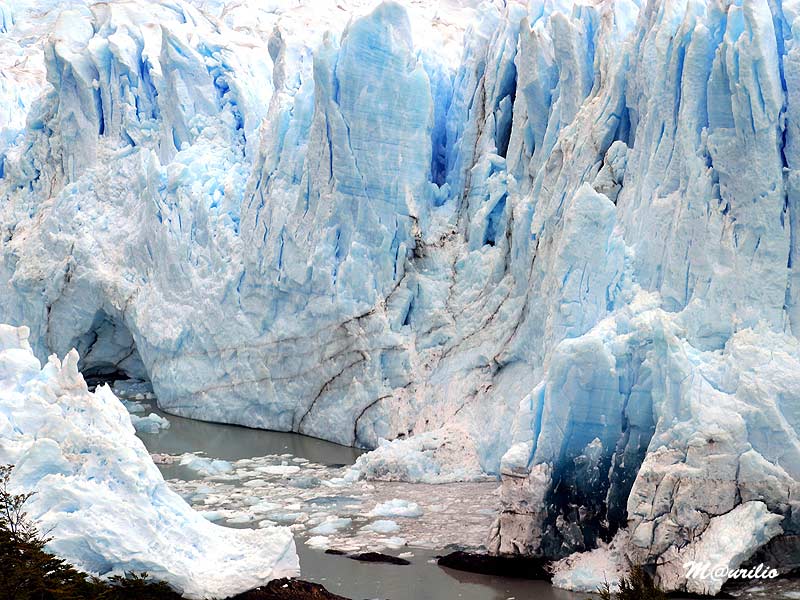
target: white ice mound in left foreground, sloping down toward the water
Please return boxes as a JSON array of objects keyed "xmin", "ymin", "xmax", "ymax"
[{"xmin": 0, "ymin": 325, "xmax": 299, "ymax": 598}]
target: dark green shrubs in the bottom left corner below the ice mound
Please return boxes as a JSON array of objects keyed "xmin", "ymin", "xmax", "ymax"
[{"xmin": 0, "ymin": 465, "xmax": 180, "ymax": 600}]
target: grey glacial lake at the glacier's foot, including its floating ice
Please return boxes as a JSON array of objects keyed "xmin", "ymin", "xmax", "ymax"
[{"xmin": 134, "ymin": 403, "xmax": 800, "ymax": 600}]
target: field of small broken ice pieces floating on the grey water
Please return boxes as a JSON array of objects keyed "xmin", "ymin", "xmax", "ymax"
[{"xmin": 153, "ymin": 454, "xmax": 498, "ymax": 552}]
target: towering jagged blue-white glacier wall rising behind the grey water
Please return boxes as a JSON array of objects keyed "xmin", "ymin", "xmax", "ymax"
[{"xmin": 0, "ymin": 0, "xmax": 800, "ymax": 593}]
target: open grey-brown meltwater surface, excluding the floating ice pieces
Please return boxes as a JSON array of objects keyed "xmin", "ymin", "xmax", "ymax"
[{"xmin": 140, "ymin": 406, "xmax": 588, "ymax": 600}]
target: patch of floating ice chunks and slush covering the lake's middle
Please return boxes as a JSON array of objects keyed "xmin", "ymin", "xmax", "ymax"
[{"xmin": 149, "ymin": 446, "xmax": 499, "ymax": 552}]
